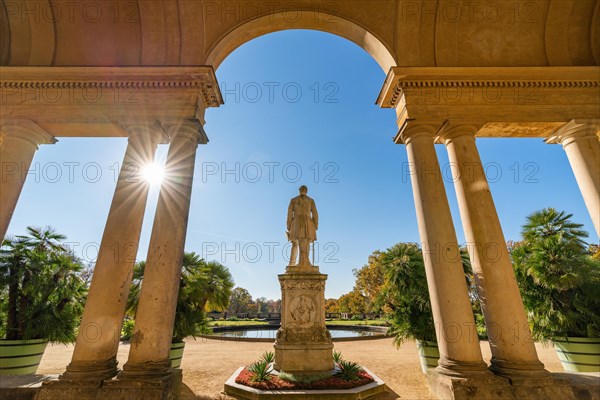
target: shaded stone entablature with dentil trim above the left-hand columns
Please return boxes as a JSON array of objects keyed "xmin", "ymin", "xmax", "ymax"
[{"xmin": 0, "ymin": 66, "xmax": 223, "ymax": 138}]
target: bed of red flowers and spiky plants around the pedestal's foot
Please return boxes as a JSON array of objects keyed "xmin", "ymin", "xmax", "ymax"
[{"xmin": 235, "ymin": 368, "xmax": 374, "ymax": 390}]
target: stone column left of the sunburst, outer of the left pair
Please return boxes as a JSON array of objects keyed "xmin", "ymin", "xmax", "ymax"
[{"xmin": 60, "ymin": 124, "xmax": 166, "ymax": 381}]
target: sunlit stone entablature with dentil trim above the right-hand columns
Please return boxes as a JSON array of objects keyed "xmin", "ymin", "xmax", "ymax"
[{"xmin": 377, "ymin": 67, "xmax": 600, "ymax": 138}]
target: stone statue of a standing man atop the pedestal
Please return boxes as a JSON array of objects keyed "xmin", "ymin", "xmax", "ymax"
[{"xmin": 287, "ymin": 185, "xmax": 319, "ymax": 266}]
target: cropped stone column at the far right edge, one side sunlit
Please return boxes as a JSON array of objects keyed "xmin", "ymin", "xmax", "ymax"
[{"xmin": 546, "ymin": 121, "xmax": 600, "ymax": 236}]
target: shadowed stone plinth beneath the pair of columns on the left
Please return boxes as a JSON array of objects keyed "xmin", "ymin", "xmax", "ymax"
[{"xmin": 35, "ymin": 369, "xmax": 182, "ymax": 400}]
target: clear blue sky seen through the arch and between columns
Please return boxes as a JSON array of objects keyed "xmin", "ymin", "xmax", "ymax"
[{"xmin": 9, "ymin": 30, "xmax": 598, "ymax": 298}]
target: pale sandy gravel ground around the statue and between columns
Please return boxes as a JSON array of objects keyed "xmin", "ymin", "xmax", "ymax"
[{"xmin": 38, "ymin": 339, "xmax": 562, "ymax": 400}]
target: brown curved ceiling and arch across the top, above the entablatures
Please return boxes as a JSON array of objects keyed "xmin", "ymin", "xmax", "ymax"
[{"xmin": 0, "ymin": 0, "xmax": 600, "ymax": 70}]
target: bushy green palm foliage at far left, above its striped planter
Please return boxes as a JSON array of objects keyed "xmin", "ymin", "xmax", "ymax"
[{"xmin": 0, "ymin": 227, "xmax": 87, "ymax": 343}]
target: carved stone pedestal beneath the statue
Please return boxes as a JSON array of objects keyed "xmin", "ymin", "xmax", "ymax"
[{"xmin": 274, "ymin": 266, "xmax": 333, "ymax": 375}]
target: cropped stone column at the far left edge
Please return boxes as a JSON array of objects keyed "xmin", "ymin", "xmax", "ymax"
[{"xmin": 0, "ymin": 119, "xmax": 56, "ymax": 242}]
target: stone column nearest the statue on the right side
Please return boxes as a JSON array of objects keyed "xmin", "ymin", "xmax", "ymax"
[{"xmin": 396, "ymin": 125, "xmax": 487, "ymax": 376}]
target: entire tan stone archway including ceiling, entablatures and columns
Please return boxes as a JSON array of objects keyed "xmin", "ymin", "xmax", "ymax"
[{"xmin": 0, "ymin": 0, "xmax": 600, "ymax": 398}]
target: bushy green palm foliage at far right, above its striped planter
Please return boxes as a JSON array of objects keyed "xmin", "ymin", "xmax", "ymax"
[{"xmin": 511, "ymin": 208, "xmax": 600, "ymax": 340}]
